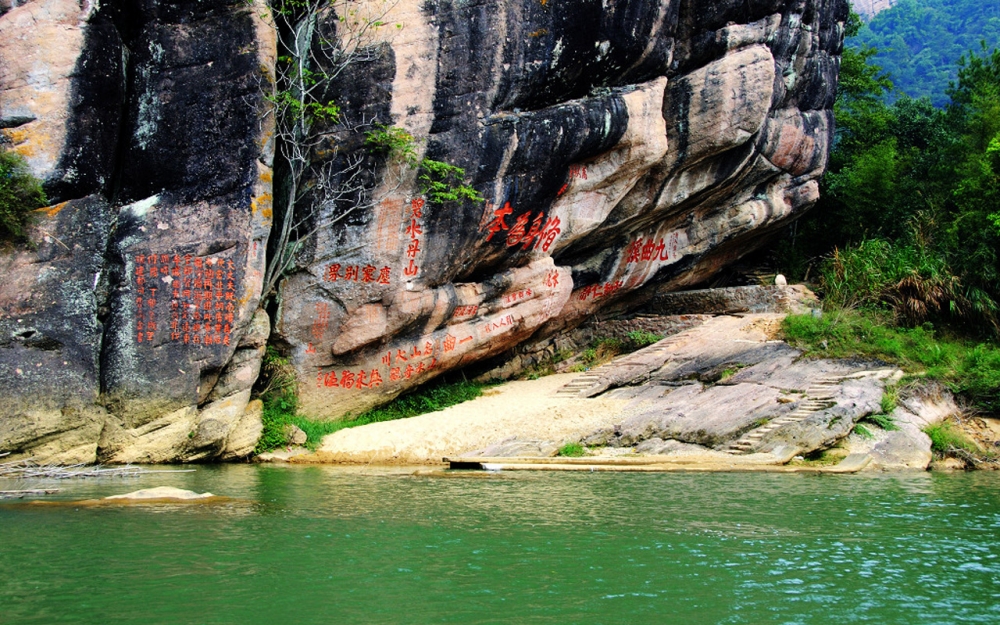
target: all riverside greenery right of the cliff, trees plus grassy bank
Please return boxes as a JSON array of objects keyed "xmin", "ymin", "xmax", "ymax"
[{"xmin": 772, "ymin": 13, "xmax": 1000, "ymax": 459}]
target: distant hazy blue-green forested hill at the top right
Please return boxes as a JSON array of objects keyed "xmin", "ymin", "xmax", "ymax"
[{"xmin": 848, "ymin": 0, "xmax": 1000, "ymax": 106}]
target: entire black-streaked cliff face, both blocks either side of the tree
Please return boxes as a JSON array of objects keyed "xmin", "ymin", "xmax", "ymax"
[{"xmin": 0, "ymin": 0, "xmax": 847, "ymax": 461}]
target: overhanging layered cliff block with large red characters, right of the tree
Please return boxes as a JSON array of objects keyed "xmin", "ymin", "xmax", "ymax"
[{"xmin": 275, "ymin": 0, "xmax": 847, "ymax": 418}]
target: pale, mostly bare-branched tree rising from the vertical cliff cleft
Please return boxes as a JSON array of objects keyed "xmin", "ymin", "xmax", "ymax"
[{"xmin": 263, "ymin": 0, "xmax": 402, "ymax": 299}]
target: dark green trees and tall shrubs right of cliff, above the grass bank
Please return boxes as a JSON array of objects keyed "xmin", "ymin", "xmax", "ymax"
[{"xmin": 778, "ymin": 16, "xmax": 1000, "ymax": 334}]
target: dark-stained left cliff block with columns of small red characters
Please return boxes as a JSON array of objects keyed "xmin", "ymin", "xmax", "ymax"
[{"xmin": 0, "ymin": 0, "xmax": 275, "ymax": 462}]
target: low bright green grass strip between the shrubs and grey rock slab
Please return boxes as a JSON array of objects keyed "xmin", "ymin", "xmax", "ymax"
[{"xmin": 782, "ymin": 309, "xmax": 1000, "ymax": 414}]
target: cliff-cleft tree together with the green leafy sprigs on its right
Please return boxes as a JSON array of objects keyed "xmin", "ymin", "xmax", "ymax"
[{"xmin": 263, "ymin": 0, "xmax": 483, "ymax": 300}]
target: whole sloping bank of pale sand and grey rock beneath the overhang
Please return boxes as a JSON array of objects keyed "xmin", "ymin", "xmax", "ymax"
[{"xmin": 282, "ymin": 315, "xmax": 896, "ymax": 464}]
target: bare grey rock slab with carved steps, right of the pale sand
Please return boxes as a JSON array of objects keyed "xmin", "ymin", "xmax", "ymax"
[{"xmin": 576, "ymin": 314, "xmax": 890, "ymax": 453}]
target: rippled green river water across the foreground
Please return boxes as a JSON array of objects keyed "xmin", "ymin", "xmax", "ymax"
[{"xmin": 0, "ymin": 465, "xmax": 1000, "ymax": 625}]
